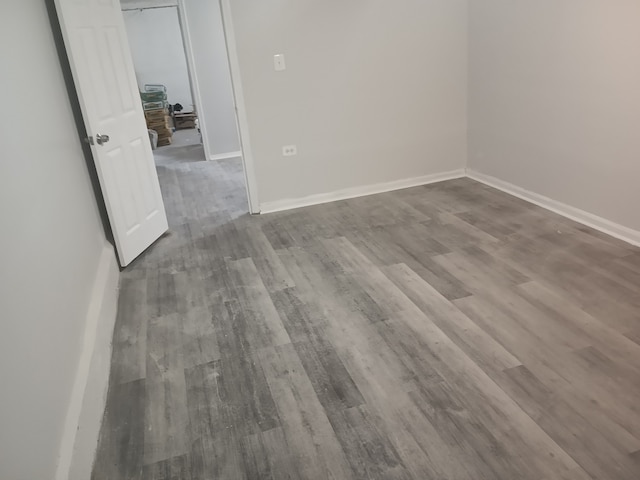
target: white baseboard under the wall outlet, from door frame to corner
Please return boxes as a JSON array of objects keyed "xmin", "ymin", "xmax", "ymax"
[{"xmin": 260, "ymin": 169, "xmax": 465, "ymax": 214}]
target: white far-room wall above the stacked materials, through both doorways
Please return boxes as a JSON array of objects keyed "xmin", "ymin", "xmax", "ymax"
[{"xmin": 123, "ymin": 7, "xmax": 194, "ymax": 111}]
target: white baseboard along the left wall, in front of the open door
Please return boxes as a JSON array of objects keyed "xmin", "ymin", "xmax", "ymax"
[{"xmin": 55, "ymin": 243, "xmax": 120, "ymax": 480}]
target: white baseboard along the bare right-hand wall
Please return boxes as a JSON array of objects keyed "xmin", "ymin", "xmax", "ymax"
[{"xmin": 467, "ymin": 169, "xmax": 640, "ymax": 247}]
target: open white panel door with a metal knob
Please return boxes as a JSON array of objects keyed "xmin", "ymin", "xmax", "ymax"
[{"xmin": 55, "ymin": 0, "xmax": 168, "ymax": 267}]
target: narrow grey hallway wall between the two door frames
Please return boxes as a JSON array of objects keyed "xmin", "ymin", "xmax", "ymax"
[{"xmin": 182, "ymin": 0, "xmax": 240, "ymax": 157}]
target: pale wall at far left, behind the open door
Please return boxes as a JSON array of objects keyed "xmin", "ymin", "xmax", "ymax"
[{"xmin": 0, "ymin": 0, "xmax": 115, "ymax": 480}]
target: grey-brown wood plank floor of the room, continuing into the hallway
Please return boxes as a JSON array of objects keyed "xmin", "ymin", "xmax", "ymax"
[{"xmin": 93, "ymin": 132, "xmax": 640, "ymax": 480}]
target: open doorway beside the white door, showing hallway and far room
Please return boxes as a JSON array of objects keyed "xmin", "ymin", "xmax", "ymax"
[{"xmin": 121, "ymin": 0, "xmax": 249, "ymax": 221}]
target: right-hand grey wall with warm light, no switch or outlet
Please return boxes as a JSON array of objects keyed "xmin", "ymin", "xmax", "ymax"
[{"xmin": 469, "ymin": 0, "xmax": 640, "ymax": 230}]
